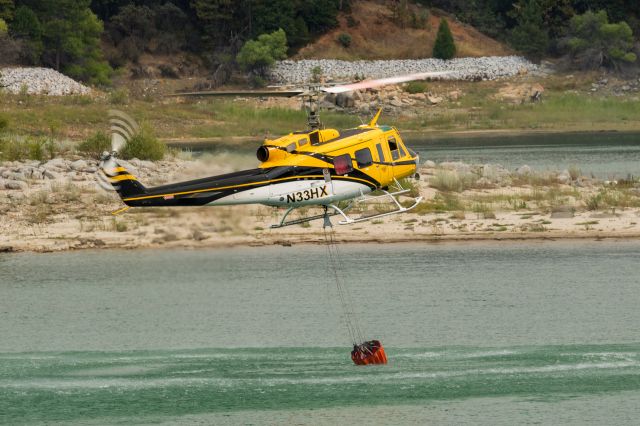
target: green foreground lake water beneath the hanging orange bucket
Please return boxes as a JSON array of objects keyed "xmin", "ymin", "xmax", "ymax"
[{"xmin": 0, "ymin": 241, "xmax": 640, "ymax": 425}]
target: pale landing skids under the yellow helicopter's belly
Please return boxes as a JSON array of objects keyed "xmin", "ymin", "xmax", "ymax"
[{"xmin": 271, "ymin": 180, "xmax": 422, "ymax": 229}]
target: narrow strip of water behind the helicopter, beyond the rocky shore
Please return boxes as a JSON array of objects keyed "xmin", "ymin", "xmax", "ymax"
[{"xmin": 180, "ymin": 132, "xmax": 640, "ymax": 179}]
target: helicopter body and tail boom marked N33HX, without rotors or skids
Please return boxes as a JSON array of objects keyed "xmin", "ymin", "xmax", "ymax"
[{"xmin": 103, "ymin": 126, "xmax": 418, "ymax": 207}]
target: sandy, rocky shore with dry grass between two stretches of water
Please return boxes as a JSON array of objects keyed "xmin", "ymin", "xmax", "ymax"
[{"xmin": 0, "ymin": 157, "xmax": 640, "ymax": 252}]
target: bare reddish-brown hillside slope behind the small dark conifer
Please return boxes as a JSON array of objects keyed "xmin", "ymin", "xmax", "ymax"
[{"xmin": 293, "ymin": 0, "xmax": 513, "ymax": 60}]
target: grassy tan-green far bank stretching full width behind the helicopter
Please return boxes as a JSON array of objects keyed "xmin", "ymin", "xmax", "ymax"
[{"xmin": 0, "ymin": 76, "xmax": 640, "ymax": 145}]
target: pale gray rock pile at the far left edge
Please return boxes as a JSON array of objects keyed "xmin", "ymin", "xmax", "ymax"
[{"xmin": 0, "ymin": 68, "xmax": 91, "ymax": 96}]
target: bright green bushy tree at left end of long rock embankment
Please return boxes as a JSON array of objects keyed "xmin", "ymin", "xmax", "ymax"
[{"xmin": 236, "ymin": 29, "xmax": 287, "ymax": 76}]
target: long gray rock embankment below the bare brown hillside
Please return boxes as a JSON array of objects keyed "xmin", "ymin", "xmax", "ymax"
[{"xmin": 271, "ymin": 56, "xmax": 538, "ymax": 84}]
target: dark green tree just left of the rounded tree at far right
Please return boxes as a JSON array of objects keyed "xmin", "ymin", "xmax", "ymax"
[{"xmin": 509, "ymin": 0, "xmax": 549, "ymax": 59}]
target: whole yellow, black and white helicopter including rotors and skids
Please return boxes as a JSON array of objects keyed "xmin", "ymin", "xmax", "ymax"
[{"xmin": 99, "ymin": 72, "xmax": 446, "ymax": 228}]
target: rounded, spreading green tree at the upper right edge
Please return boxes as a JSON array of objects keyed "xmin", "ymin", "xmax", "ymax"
[{"xmin": 562, "ymin": 10, "xmax": 637, "ymax": 70}]
